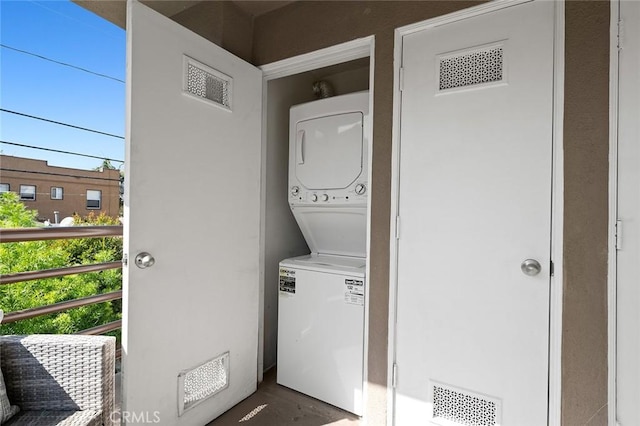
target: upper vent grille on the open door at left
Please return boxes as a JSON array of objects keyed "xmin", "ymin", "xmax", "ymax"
[{"xmin": 184, "ymin": 56, "xmax": 232, "ymax": 109}]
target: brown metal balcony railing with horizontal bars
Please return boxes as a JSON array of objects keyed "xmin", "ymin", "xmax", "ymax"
[{"xmin": 0, "ymin": 226, "xmax": 123, "ymax": 357}]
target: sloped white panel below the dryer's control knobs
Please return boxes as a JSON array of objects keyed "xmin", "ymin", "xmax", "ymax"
[{"xmin": 291, "ymin": 206, "xmax": 367, "ymax": 257}]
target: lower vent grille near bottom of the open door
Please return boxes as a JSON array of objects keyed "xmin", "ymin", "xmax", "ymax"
[{"xmin": 178, "ymin": 352, "xmax": 229, "ymax": 415}]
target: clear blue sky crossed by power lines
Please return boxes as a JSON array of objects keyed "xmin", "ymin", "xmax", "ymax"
[{"xmin": 0, "ymin": 0, "xmax": 126, "ymax": 169}]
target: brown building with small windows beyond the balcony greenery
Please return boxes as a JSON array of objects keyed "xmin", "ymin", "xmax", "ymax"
[{"xmin": 0, "ymin": 155, "xmax": 120, "ymax": 223}]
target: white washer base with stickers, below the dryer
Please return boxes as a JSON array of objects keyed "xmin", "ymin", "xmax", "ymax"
[{"xmin": 277, "ymin": 255, "xmax": 365, "ymax": 415}]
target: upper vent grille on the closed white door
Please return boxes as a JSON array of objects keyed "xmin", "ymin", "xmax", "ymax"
[{"xmin": 439, "ymin": 44, "xmax": 504, "ymax": 90}]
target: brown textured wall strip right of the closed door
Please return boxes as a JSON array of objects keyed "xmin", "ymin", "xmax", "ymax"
[{"xmin": 562, "ymin": 1, "xmax": 610, "ymax": 426}]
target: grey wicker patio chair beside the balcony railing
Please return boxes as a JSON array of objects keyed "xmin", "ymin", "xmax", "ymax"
[{"xmin": 0, "ymin": 334, "xmax": 117, "ymax": 426}]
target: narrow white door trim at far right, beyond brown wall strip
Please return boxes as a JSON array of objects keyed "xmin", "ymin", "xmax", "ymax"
[{"xmin": 607, "ymin": 0, "xmax": 620, "ymax": 425}]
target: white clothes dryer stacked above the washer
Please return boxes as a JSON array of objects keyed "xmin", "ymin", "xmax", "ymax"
[{"xmin": 289, "ymin": 92, "xmax": 369, "ymax": 257}]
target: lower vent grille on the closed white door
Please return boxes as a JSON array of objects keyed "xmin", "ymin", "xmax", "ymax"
[{"xmin": 433, "ymin": 384, "xmax": 500, "ymax": 426}]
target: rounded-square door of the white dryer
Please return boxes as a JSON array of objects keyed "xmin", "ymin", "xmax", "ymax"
[{"xmin": 291, "ymin": 112, "xmax": 363, "ymax": 190}]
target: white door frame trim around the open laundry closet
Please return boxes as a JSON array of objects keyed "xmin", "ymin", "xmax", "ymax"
[{"xmin": 257, "ymin": 35, "xmax": 375, "ymax": 412}]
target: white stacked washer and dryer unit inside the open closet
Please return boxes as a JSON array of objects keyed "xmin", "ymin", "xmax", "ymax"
[{"xmin": 277, "ymin": 92, "xmax": 369, "ymax": 415}]
